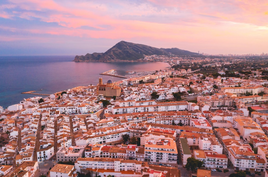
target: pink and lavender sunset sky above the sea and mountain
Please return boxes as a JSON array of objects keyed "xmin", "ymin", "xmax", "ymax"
[{"xmin": 0, "ymin": 0, "xmax": 268, "ymax": 55}]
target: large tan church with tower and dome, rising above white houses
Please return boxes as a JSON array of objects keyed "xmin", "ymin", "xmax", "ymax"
[{"xmin": 97, "ymin": 78, "xmax": 121, "ymax": 97}]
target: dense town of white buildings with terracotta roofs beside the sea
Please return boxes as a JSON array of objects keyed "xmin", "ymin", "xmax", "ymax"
[{"xmin": 0, "ymin": 59, "xmax": 268, "ymax": 177}]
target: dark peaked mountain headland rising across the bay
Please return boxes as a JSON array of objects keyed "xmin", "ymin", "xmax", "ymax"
[{"xmin": 74, "ymin": 41, "xmax": 198, "ymax": 62}]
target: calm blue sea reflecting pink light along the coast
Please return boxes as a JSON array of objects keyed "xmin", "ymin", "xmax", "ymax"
[{"xmin": 0, "ymin": 56, "xmax": 168, "ymax": 108}]
